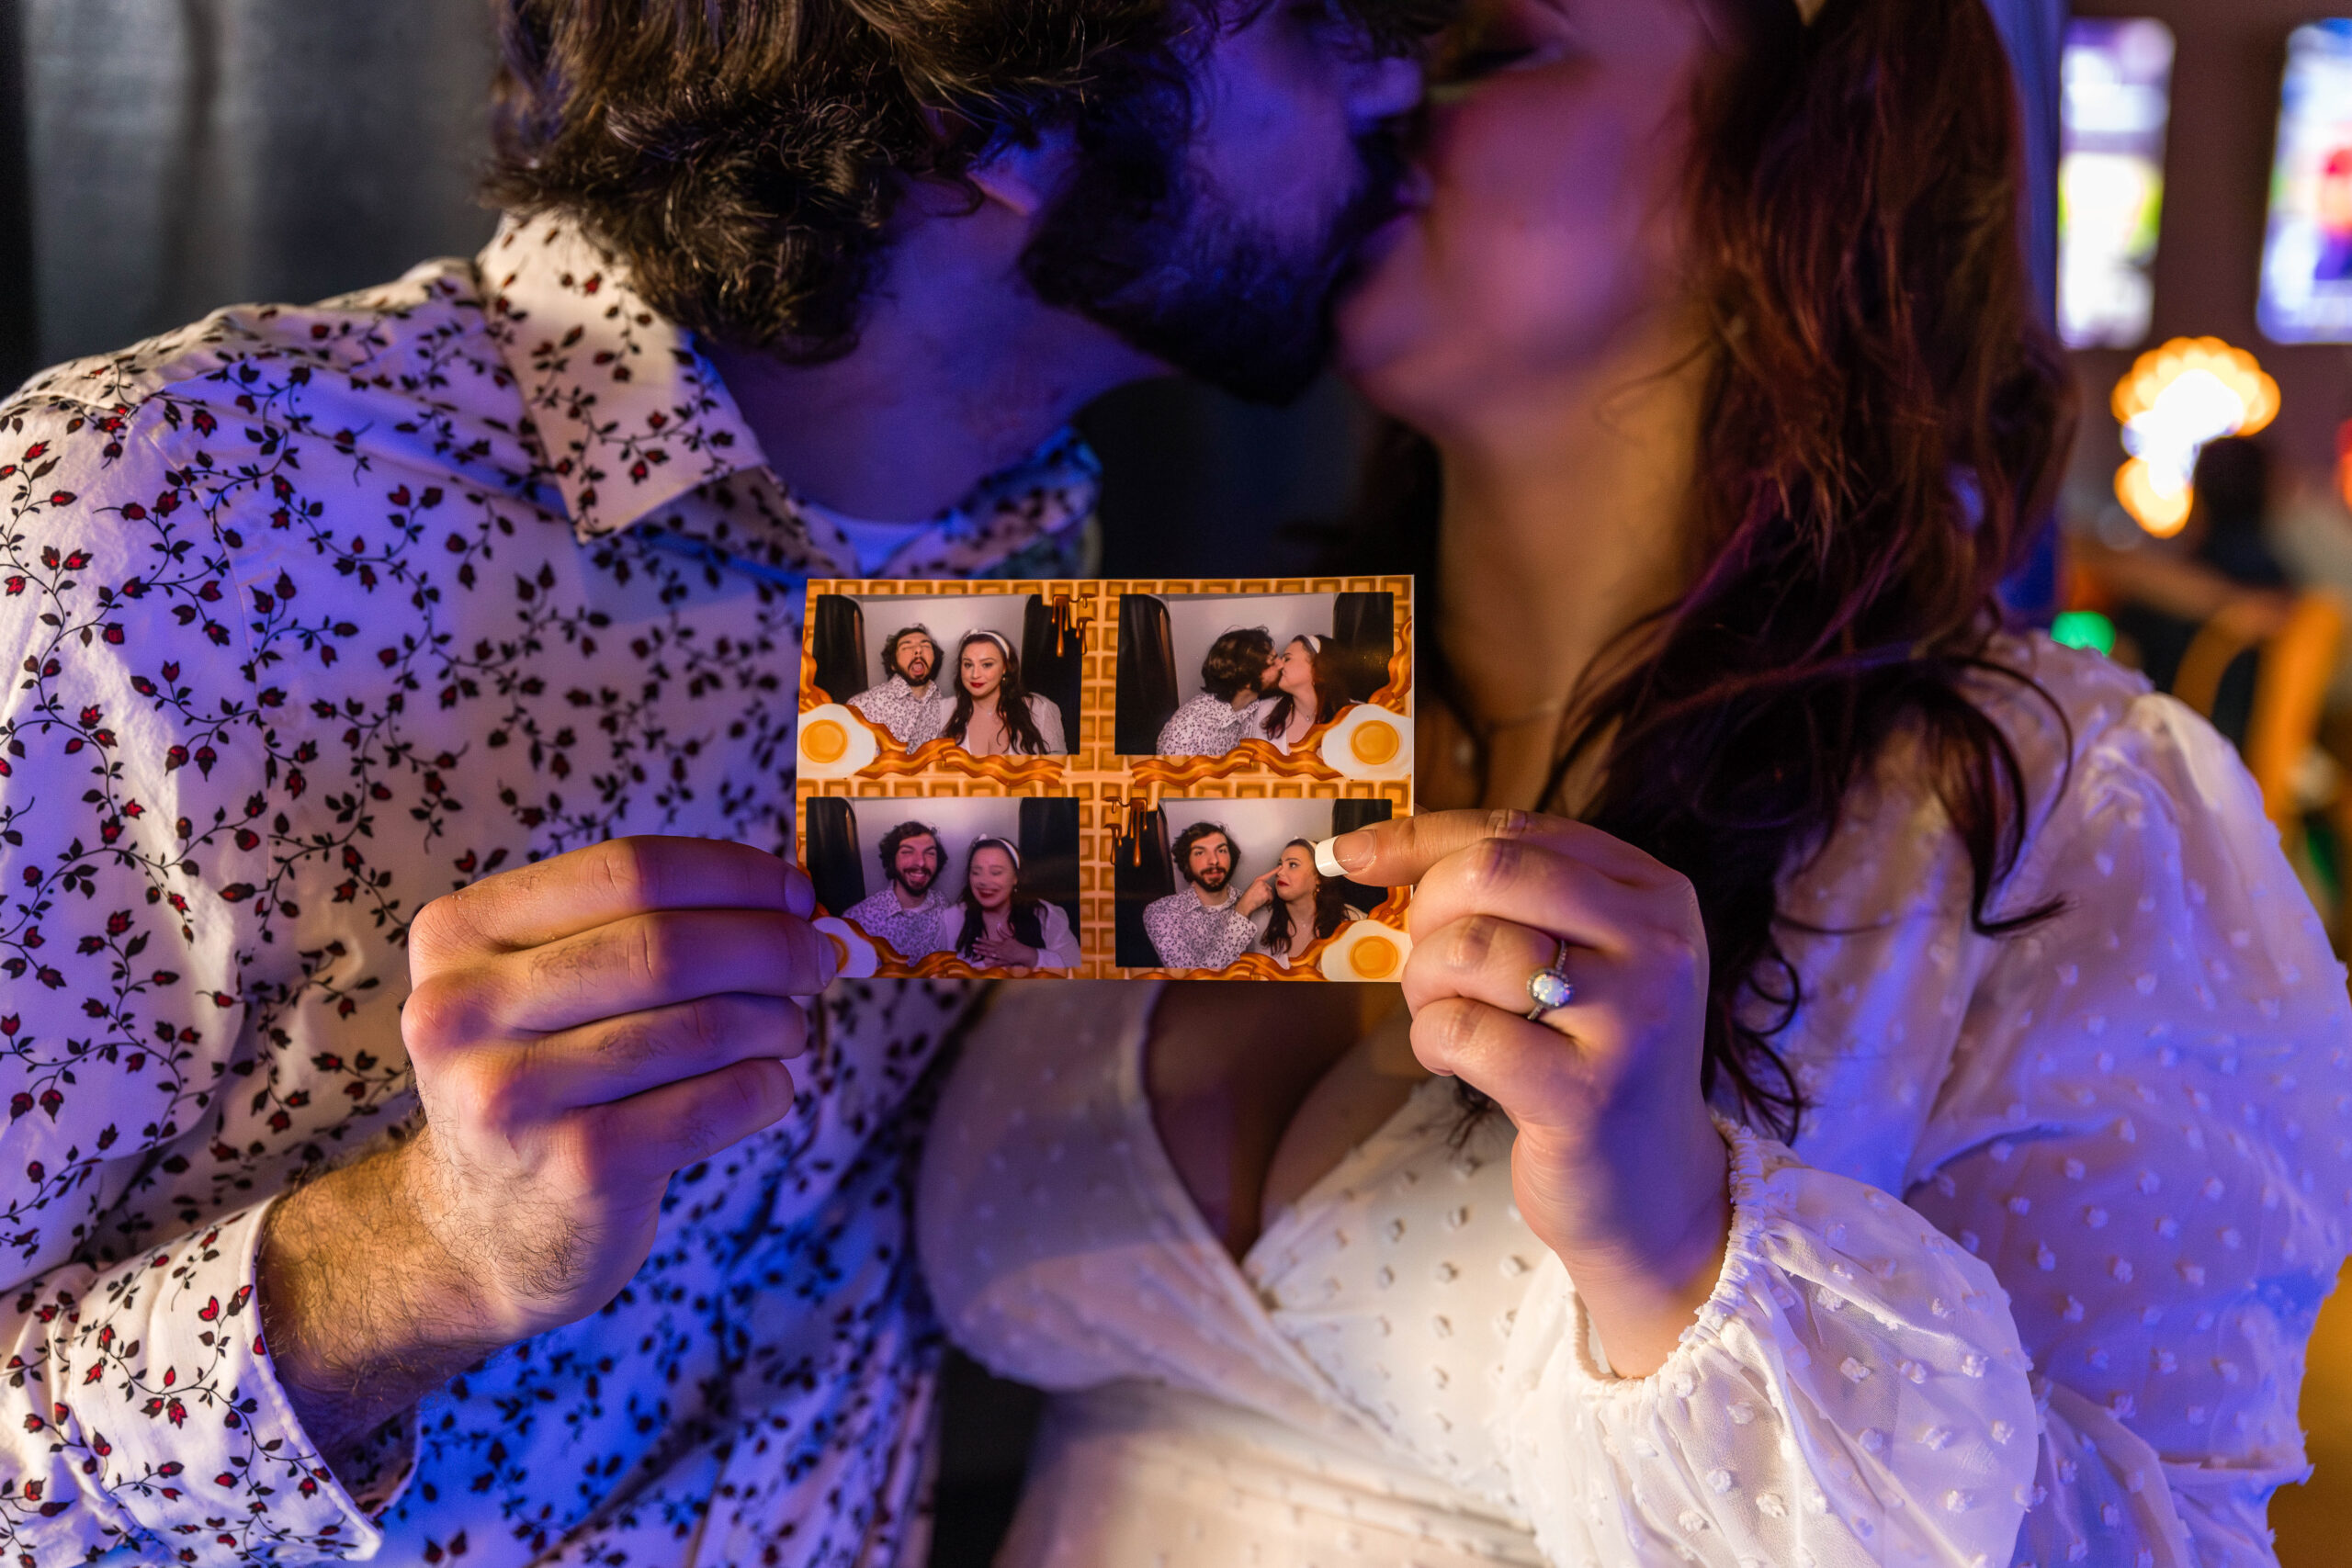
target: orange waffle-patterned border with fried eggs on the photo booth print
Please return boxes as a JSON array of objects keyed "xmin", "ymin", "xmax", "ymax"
[{"xmin": 797, "ymin": 576, "xmax": 1414, "ymax": 980}]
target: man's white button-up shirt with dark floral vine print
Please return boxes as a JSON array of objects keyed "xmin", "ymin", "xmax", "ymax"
[{"xmin": 0, "ymin": 219, "xmax": 1096, "ymax": 1568}]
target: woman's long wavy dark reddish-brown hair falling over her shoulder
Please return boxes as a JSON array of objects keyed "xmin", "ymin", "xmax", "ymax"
[{"xmin": 1366, "ymin": 0, "xmax": 2075, "ymax": 1135}]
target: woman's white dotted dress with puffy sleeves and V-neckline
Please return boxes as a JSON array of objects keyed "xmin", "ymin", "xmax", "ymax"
[{"xmin": 917, "ymin": 642, "xmax": 2352, "ymax": 1568}]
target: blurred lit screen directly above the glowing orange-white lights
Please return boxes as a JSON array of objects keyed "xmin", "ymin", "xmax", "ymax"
[{"xmin": 2058, "ymin": 17, "xmax": 2173, "ymax": 348}]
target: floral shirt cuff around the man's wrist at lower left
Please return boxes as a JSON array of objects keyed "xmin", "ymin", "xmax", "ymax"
[{"xmin": 56, "ymin": 1203, "xmax": 416, "ymax": 1563}]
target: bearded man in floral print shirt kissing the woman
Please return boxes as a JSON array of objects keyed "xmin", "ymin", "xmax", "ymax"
[{"xmin": 0, "ymin": 0, "xmax": 1419, "ymax": 1568}]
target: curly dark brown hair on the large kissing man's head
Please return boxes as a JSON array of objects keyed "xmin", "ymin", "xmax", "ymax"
[{"xmin": 484, "ymin": 0, "xmax": 1444, "ymax": 365}]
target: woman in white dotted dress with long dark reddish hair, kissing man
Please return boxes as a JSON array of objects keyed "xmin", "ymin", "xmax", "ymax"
[{"xmin": 917, "ymin": 0, "xmax": 2352, "ymax": 1568}]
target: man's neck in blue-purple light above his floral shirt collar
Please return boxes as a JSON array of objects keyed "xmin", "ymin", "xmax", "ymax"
[{"xmin": 701, "ymin": 178, "xmax": 1164, "ymax": 522}]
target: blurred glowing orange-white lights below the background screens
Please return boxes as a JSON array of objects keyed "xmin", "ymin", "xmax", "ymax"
[{"xmin": 2114, "ymin": 339, "xmax": 2279, "ymax": 538}]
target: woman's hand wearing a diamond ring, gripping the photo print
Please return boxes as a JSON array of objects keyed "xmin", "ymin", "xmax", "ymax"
[{"xmin": 1331, "ymin": 811, "xmax": 1731, "ymax": 1375}]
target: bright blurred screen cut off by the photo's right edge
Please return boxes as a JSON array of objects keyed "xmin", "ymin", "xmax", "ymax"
[{"xmin": 2260, "ymin": 18, "xmax": 2352, "ymax": 344}]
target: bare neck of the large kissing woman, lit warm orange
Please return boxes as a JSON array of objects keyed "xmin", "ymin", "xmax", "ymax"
[{"xmin": 1437, "ymin": 305, "xmax": 1710, "ymax": 804}]
